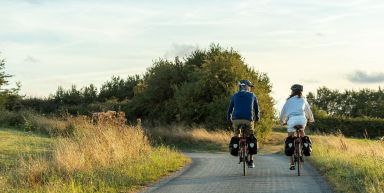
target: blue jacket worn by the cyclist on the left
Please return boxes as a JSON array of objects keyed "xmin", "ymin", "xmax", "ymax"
[{"xmin": 227, "ymin": 91, "xmax": 260, "ymax": 121}]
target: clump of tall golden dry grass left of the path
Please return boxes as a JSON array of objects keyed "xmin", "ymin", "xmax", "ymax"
[{"xmin": 53, "ymin": 119, "xmax": 152, "ymax": 172}]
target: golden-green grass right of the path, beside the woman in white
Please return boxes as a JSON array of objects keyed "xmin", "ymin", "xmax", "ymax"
[{"xmin": 311, "ymin": 135, "xmax": 384, "ymax": 193}]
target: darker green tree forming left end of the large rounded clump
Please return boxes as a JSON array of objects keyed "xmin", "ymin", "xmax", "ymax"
[{"xmin": 128, "ymin": 58, "xmax": 186, "ymax": 123}]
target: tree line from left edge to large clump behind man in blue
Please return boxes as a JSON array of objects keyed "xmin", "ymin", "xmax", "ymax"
[{"xmin": 0, "ymin": 45, "xmax": 274, "ymax": 135}]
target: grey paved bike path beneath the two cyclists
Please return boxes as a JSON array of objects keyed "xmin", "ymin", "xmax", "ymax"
[{"xmin": 143, "ymin": 153, "xmax": 332, "ymax": 193}]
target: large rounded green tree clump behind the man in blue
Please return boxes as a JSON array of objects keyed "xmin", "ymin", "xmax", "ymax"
[{"xmin": 127, "ymin": 45, "xmax": 274, "ymax": 137}]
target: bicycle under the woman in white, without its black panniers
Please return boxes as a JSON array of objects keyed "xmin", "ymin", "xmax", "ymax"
[{"xmin": 292, "ymin": 125, "xmax": 304, "ymax": 176}]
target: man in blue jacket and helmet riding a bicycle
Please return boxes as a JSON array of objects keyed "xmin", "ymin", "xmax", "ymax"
[{"xmin": 227, "ymin": 80, "xmax": 260, "ymax": 168}]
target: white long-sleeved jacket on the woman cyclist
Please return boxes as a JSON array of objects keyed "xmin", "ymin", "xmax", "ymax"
[{"xmin": 280, "ymin": 96, "xmax": 315, "ymax": 124}]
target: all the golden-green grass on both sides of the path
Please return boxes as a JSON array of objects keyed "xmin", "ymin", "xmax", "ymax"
[{"xmin": 0, "ymin": 119, "xmax": 384, "ymax": 193}]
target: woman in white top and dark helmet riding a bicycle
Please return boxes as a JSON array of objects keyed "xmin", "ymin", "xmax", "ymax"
[{"xmin": 280, "ymin": 84, "xmax": 315, "ymax": 170}]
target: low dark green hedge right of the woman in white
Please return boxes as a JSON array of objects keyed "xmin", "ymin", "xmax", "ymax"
[{"xmin": 309, "ymin": 116, "xmax": 384, "ymax": 138}]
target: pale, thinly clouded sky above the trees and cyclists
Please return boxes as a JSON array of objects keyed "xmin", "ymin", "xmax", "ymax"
[{"xmin": 0, "ymin": 0, "xmax": 384, "ymax": 108}]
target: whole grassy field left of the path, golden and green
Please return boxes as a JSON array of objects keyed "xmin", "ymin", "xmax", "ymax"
[{"xmin": 0, "ymin": 119, "xmax": 190, "ymax": 192}]
